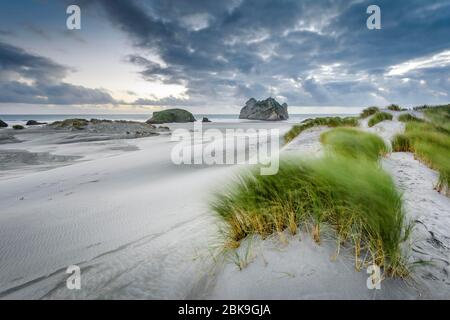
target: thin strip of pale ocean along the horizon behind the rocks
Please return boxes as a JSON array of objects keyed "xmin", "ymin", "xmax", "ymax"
[{"xmin": 0, "ymin": 113, "xmax": 357, "ymax": 126}]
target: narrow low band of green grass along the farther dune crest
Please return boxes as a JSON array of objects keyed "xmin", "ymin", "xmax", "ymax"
[{"xmin": 284, "ymin": 117, "xmax": 358, "ymax": 143}]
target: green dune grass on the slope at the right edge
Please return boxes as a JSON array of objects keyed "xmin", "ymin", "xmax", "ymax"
[{"xmin": 392, "ymin": 106, "xmax": 450, "ymax": 196}]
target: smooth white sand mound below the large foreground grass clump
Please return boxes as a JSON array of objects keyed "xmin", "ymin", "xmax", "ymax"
[{"xmin": 202, "ymin": 232, "xmax": 419, "ymax": 299}]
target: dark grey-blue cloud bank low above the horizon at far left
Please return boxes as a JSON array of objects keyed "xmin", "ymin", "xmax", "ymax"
[{"xmin": 0, "ymin": 42, "xmax": 115, "ymax": 104}]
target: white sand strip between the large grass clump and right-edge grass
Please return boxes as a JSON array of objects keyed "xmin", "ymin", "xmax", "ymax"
[{"xmin": 365, "ymin": 112, "xmax": 450, "ymax": 299}]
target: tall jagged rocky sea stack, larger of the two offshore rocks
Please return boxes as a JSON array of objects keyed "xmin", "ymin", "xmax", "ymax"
[{"xmin": 239, "ymin": 97, "xmax": 289, "ymax": 121}]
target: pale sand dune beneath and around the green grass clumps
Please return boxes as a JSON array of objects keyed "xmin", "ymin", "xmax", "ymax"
[{"xmin": 204, "ymin": 115, "xmax": 450, "ymax": 299}]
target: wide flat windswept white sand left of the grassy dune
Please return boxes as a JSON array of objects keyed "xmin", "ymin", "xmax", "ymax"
[{"xmin": 0, "ymin": 122, "xmax": 290, "ymax": 299}]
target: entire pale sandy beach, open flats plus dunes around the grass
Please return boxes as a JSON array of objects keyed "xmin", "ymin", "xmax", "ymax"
[{"xmin": 0, "ymin": 111, "xmax": 450, "ymax": 299}]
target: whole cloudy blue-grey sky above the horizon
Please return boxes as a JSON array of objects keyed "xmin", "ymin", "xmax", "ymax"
[{"xmin": 0, "ymin": 0, "xmax": 450, "ymax": 114}]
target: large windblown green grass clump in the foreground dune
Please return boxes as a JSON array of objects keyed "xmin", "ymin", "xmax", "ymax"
[{"xmin": 212, "ymin": 128, "xmax": 409, "ymax": 276}]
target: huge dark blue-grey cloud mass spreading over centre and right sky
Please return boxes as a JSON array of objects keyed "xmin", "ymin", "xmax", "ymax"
[{"xmin": 90, "ymin": 0, "xmax": 450, "ymax": 105}]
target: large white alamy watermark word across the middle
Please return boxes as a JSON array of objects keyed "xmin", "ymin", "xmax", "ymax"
[{"xmin": 171, "ymin": 122, "xmax": 280, "ymax": 175}]
